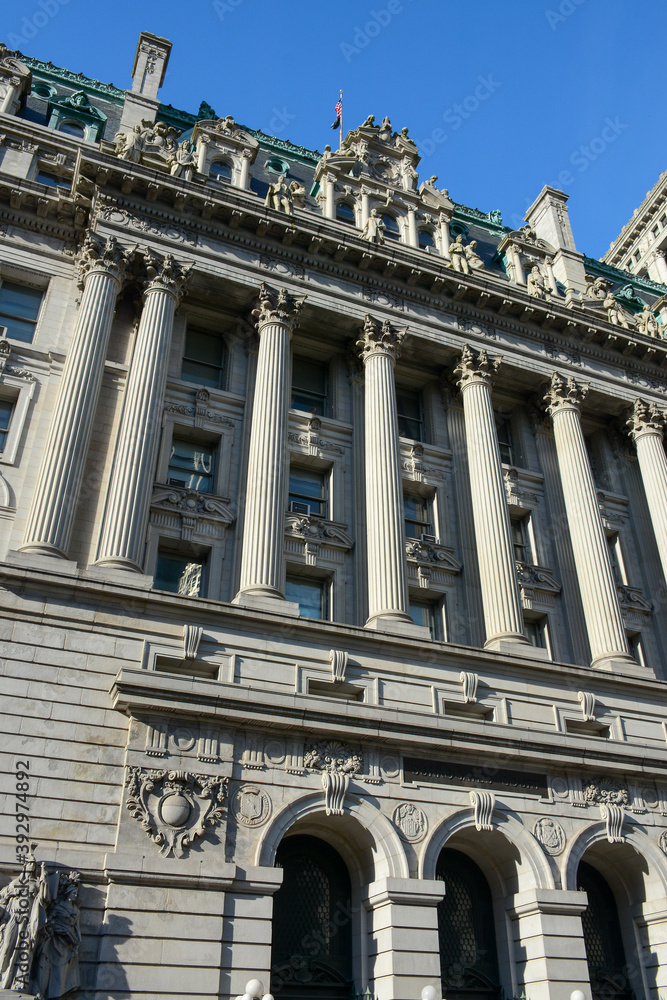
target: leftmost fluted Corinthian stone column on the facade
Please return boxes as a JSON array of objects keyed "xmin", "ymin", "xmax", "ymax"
[{"xmin": 21, "ymin": 234, "xmax": 133, "ymax": 558}]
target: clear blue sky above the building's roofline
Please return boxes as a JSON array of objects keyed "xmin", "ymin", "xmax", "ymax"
[{"xmin": 6, "ymin": 0, "xmax": 667, "ymax": 256}]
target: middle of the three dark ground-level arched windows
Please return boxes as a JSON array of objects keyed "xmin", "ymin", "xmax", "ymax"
[{"xmin": 436, "ymin": 847, "xmax": 500, "ymax": 1000}]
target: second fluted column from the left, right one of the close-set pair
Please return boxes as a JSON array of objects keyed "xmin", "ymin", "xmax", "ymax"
[{"xmin": 96, "ymin": 254, "xmax": 191, "ymax": 573}]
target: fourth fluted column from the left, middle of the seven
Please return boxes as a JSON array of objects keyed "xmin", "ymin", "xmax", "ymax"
[{"xmin": 357, "ymin": 316, "xmax": 426, "ymax": 635}]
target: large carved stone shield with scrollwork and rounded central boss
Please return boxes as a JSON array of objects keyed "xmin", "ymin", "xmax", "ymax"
[{"xmin": 126, "ymin": 767, "xmax": 227, "ymax": 858}]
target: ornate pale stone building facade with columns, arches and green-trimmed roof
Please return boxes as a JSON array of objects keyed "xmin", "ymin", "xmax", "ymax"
[{"xmin": 0, "ymin": 27, "xmax": 667, "ymax": 1000}]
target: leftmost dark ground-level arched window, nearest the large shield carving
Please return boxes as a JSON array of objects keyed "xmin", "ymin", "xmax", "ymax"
[{"xmin": 271, "ymin": 836, "xmax": 354, "ymax": 1000}]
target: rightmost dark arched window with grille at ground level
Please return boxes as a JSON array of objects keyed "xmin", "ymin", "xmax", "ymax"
[{"xmin": 577, "ymin": 861, "xmax": 632, "ymax": 1000}]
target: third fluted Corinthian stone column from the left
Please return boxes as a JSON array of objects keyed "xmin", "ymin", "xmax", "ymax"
[{"xmin": 234, "ymin": 284, "xmax": 303, "ymax": 613}]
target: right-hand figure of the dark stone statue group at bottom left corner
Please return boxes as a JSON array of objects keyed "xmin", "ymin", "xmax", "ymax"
[{"xmin": 32, "ymin": 872, "xmax": 81, "ymax": 1000}]
